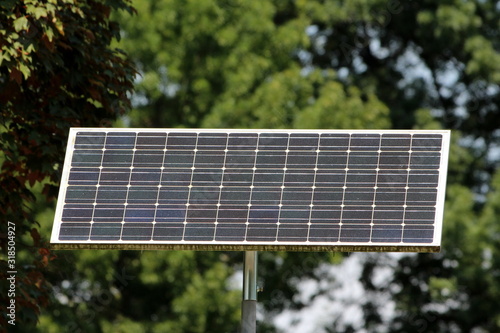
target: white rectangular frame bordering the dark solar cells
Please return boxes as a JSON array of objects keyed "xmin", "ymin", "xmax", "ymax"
[{"xmin": 50, "ymin": 127, "xmax": 450, "ymax": 252}]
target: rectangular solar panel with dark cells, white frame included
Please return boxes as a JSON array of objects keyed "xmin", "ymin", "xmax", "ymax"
[{"xmin": 51, "ymin": 128, "xmax": 450, "ymax": 252}]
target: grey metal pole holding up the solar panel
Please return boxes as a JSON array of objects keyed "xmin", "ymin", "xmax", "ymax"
[{"xmin": 241, "ymin": 251, "xmax": 257, "ymax": 333}]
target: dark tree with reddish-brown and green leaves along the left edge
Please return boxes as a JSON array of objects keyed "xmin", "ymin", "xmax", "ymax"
[{"xmin": 0, "ymin": 0, "xmax": 135, "ymax": 328}]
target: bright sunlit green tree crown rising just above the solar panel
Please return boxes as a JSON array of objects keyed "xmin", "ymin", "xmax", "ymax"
[{"xmin": 116, "ymin": 0, "xmax": 389, "ymax": 128}]
